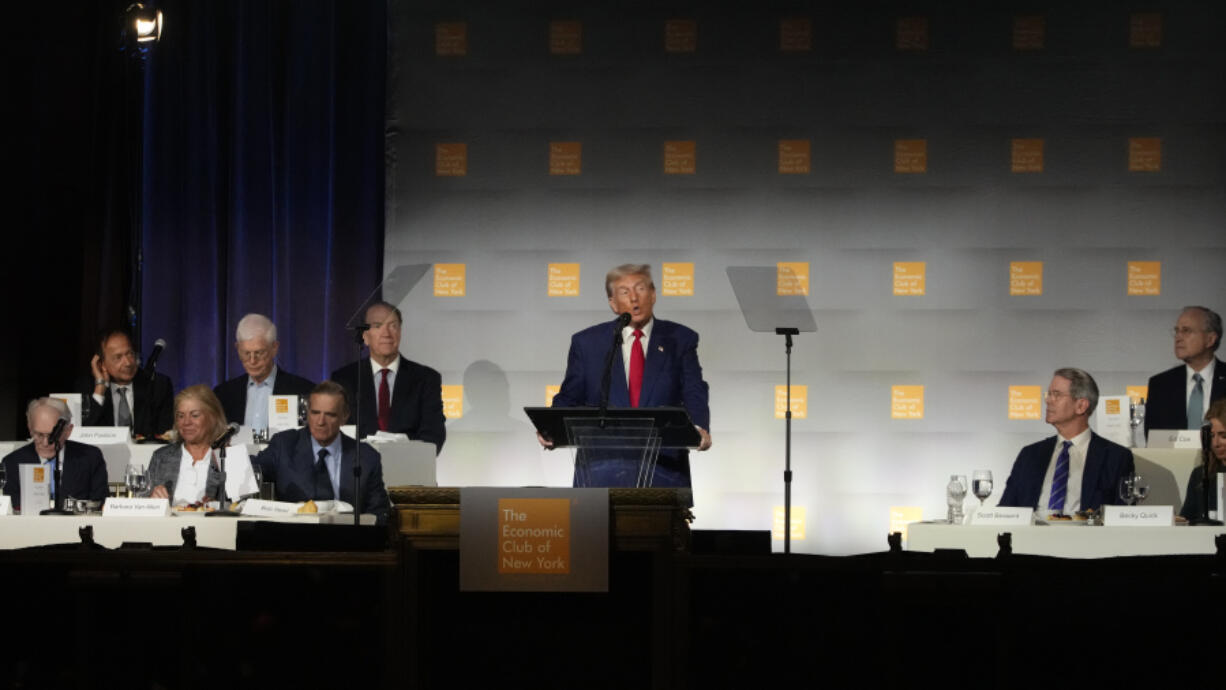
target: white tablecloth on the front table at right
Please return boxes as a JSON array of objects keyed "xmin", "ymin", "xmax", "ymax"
[{"xmin": 907, "ymin": 522, "xmax": 1226, "ymax": 558}]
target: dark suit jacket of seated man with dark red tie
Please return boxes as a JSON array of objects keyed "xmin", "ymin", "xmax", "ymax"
[{"xmin": 332, "ymin": 357, "xmax": 447, "ymax": 451}]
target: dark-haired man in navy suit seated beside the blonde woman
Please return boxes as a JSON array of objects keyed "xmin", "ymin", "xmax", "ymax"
[{"xmin": 255, "ymin": 381, "xmax": 391, "ymax": 522}]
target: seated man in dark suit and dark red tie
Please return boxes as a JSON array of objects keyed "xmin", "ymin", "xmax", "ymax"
[{"xmin": 332, "ymin": 301, "xmax": 447, "ymax": 451}]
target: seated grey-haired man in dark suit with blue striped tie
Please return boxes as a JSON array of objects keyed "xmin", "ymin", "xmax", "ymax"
[{"xmin": 1000, "ymin": 368, "xmax": 1133, "ymax": 515}]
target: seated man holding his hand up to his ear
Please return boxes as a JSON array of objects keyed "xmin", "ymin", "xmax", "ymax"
[{"xmin": 81, "ymin": 331, "xmax": 174, "ymax": 439}]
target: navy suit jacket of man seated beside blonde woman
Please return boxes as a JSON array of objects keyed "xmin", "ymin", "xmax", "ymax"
[{"xmin": 255, "ymin": 429, "xmax": 391, "ymax": 521}]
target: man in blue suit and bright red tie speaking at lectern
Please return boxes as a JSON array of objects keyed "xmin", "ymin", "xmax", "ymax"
[{"xmin": 537, "ymin": 263, "xmax": 711, "ymax": 488}]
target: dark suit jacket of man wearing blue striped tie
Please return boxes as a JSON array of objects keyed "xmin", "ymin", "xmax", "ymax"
[{"xmin": 999, "ymin": 431, "xmax": 1134, "ymax": 510}]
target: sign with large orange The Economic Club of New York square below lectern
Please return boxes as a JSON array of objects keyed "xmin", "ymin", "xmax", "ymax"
[{"xmin": 460, "ymin": 487, "xmax": 609, "ymax": 592}]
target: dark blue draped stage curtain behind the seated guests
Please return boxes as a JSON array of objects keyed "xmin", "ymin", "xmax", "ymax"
[{"xmin": 137, "ymin": 0, "xmax": 386, "ymax": 390}]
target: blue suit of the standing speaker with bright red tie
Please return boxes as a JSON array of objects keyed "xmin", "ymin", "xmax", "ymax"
[{"xmin": 553, "ymin": 319, "xmax": 711, "ymax": 488}]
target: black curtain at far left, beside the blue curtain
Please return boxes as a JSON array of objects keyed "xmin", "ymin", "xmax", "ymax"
[{"xmin": 7, "ymin": 0, "xmax": 141, "ymax": 439}]
